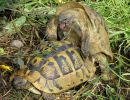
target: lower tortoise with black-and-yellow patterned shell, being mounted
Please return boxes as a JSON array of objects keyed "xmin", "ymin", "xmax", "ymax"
[{"xmin": 11, "ymin": 41, "xmax": 96, "ymax": 100}]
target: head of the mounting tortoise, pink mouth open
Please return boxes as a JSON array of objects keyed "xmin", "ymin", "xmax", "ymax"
[{"xmin": 58, "ymin": 8, "xmax": 85, "ymax": 37}]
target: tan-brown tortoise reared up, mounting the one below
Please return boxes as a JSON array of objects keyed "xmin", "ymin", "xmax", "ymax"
[{"xmin": 46, "ymin": 2, "xmax": 113, "ymax": 80}]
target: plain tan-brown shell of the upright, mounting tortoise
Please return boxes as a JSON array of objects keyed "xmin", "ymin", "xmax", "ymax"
[{"xmin": 46, "ymin": 2, "xmax": 113, "ymax": 60}]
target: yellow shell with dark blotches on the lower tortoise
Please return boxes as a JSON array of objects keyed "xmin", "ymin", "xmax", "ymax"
[{"xmin": 15, "ymin": 41, "xmax": 90, "ymax": 93}]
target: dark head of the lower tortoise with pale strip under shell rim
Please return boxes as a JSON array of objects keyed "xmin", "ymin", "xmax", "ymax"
[{"xmin": 12, "ymin": 69, "xmax": 41, "ymax": 94}]
